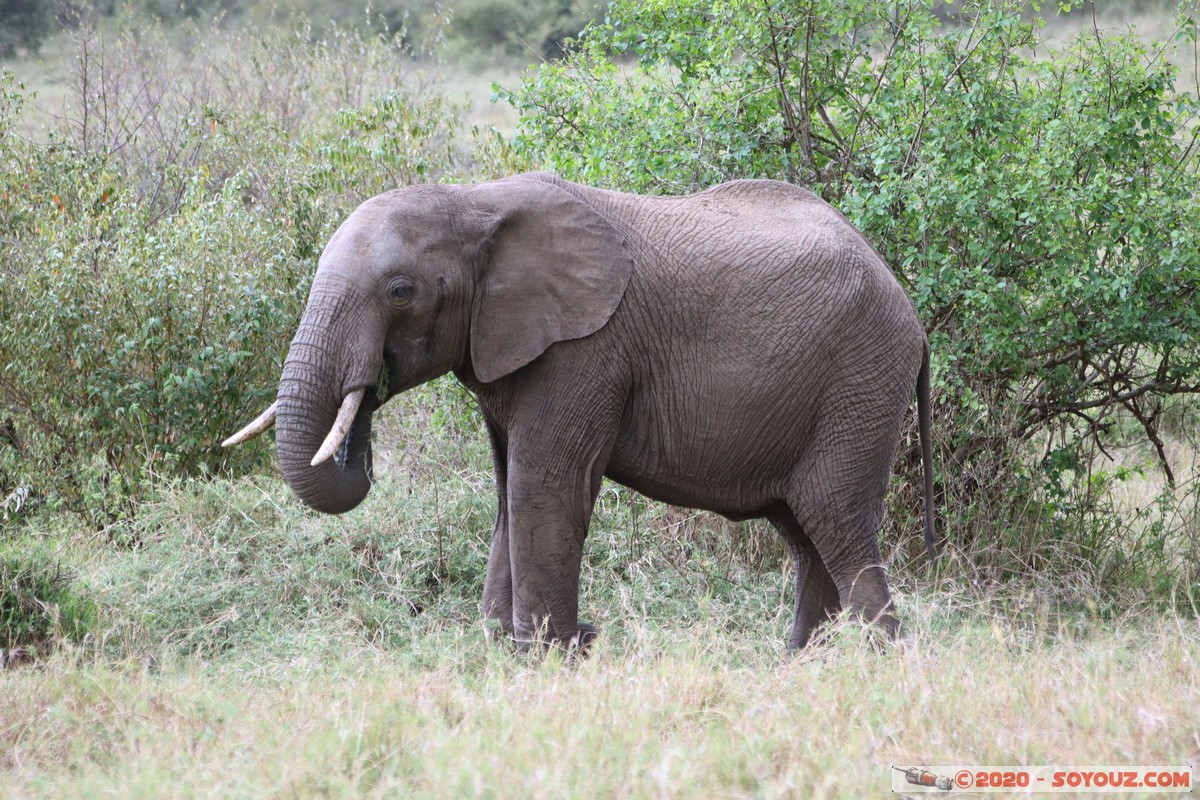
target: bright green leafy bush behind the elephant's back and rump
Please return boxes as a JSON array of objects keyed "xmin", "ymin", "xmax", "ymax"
[{"xmin": 500, "ymin": 0, "xmax": 1200, "ymax": 587}]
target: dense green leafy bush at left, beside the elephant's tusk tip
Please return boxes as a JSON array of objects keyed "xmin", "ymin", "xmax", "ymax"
[{"xmin": 0, "ymin": 161, "xmax": 304, "ymax": 524}]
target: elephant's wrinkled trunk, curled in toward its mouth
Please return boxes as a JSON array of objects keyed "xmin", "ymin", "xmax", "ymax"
[{"xmin": 275, "ymin": 284, "xmax": 382, "ymax": 513}]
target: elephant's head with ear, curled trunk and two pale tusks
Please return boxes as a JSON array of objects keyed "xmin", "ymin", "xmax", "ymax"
[{"xmin": 226, "ymin": 175, "xmax": 632, "ymax": 513}]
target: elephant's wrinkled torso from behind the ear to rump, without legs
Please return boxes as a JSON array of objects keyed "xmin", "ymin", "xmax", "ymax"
[{"xmin": 576, "ymin": 181, "xmax": 925, "ymax": 517}]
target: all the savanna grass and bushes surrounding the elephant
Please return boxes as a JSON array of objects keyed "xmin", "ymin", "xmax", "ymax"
[{"xmin": 0, "ymin": 0, "xmax": 1200, "ymax": 798}]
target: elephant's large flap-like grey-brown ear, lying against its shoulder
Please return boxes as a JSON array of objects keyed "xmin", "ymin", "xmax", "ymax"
[{"xmin": 470, "ymin": 175, "xmax": 634, "ymax": 383}]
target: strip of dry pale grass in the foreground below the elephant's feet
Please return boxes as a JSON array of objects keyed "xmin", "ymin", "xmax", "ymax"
[{"xmin": 0, "ymin": 619, "xmax": 1200, "ymax": 798}]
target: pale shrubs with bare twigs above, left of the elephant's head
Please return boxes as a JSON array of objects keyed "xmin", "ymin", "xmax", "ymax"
[{"xmin": 0, "ymin": 15, "xmax": 458, "ymax": 525}]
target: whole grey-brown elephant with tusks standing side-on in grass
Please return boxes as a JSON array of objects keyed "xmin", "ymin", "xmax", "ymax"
[{"xmin": 226, "ymin": 174, "xmax": 934, "ymax": 648}]
